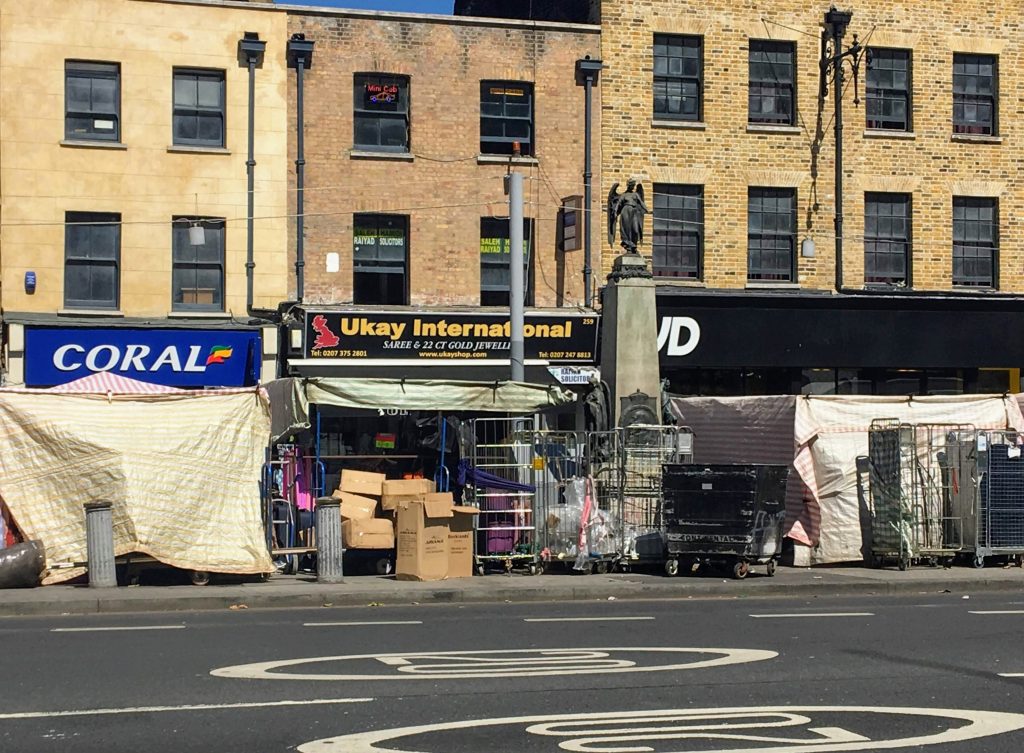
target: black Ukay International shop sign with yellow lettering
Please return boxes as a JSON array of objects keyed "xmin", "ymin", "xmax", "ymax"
[{"xmin": 303, "ymin": 310, "xmax": 598, "ymax": 364}]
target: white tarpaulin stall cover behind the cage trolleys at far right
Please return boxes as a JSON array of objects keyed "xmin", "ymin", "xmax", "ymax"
[{"xmin": 788, "ymin": 394, "xmax": 1024, "ymax": 564}]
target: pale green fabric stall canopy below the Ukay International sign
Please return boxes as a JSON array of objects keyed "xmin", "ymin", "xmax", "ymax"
[{"xmin": 265, "ymin": 377, "xmax": 575, "ymax": 440}]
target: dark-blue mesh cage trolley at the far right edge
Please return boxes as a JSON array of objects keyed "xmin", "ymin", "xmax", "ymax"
[{"xmin": 947, "ymin": 431, "xmax": 1024, "ymax": 568}]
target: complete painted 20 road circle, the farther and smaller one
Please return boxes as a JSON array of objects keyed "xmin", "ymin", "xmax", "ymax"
[{"xmin": 210, "ymin": 647, "xmax": 778, "ymax": 681}]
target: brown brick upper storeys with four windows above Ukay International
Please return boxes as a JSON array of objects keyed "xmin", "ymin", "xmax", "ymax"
[{"xmin": 289, "ymin": 7, "xmax": 601, "ymax": 307}]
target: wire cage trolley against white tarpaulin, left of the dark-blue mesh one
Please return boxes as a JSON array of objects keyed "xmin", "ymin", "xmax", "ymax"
[{"xmin": 857, "ymin": 419, "xmax": 975, "ymax": 570}]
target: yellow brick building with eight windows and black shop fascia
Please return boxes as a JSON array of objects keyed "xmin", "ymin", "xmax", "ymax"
[{"xmin": 601, "ymin": 0, "xmax": 1024, "ymax": 394}]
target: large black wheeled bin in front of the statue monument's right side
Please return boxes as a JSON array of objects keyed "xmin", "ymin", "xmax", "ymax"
[{"xmin": 663, "ymin": 464, "xmax": 790, "ymax": 579}]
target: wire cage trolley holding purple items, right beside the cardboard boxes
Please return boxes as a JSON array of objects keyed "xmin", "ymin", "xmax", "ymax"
[{"xmin": 464, "ymin": 418, "xmax": 541, "ymax": 575}]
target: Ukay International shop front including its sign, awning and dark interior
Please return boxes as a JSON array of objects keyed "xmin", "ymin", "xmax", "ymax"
[{"xmin": 269, "ymin": 307, "xmax": 599, "ymax": 562}]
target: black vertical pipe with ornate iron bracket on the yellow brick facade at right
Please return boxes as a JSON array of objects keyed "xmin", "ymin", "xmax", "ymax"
[{"xmin": 820, "ymin": 5, "xmax": 864, "ymax": 293}]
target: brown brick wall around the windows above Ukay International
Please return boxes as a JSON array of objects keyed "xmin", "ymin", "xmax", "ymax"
[{"xmin": 289, "ymin": 11, "xmax": 601, "ymax": 306}]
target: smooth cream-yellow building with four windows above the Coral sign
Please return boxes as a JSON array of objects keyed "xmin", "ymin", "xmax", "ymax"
[{"xmin": 0, "ymin": 0, "xmax": 289, "ymax": 383}]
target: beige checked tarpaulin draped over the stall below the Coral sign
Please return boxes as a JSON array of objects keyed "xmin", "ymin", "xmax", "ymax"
[{"xmin": 0, "ymin": 389, "xmax": 272, "ymax": 583}]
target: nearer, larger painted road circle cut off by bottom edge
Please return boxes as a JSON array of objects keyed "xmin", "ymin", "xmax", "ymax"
[{"xmin": 298, "ymin": 706, "xmax": 1024, "ymax": 753}]
